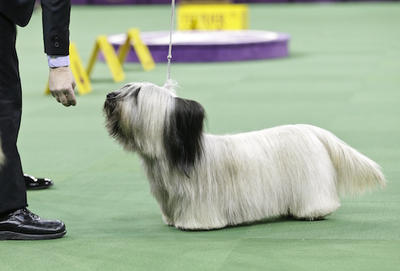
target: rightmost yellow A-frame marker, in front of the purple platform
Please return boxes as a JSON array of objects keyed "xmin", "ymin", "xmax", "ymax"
[{"xmin": 118, "ymin": 28, "xmax": 155, "ymax": 71}]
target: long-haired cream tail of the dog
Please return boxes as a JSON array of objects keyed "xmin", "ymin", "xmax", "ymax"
[{"xmin": 307, "ymin": 125, "xmax": 386, "ymax": 195}]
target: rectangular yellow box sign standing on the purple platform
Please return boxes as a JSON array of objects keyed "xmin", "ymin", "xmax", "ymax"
[{"xmin": 178, "ymin": 4, "xmax": 249, "ymax": 30}]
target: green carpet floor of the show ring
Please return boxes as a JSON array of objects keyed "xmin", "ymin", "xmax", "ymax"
[{"xmin": 0, "ymin": 3, "xmax": 400, "ymax": 271}]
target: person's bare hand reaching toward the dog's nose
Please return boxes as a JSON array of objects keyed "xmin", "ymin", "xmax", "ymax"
[{"xmin": 49, "ymin": 67, "xmax": 76, "ymax": 106}]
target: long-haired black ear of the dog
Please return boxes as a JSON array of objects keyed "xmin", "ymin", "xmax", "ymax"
[{"xmin": 164, "ymin": 98, "xmax": 205, "ymax": 177}]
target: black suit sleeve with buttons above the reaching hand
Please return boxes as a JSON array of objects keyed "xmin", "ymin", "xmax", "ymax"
[{"xmin": 41, "ymin": 0, "xmax": 71, "ymax": 56}]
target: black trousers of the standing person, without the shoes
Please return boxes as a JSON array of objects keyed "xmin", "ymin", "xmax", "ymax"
[{"xmin": 0, "ymin": 14, "xmax": 27, "ymax": 214}]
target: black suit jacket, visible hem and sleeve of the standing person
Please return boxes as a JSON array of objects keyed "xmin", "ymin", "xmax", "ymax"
[{"xmin": 0, "ymin": 0, "xmax": 71, "ymax": 56}]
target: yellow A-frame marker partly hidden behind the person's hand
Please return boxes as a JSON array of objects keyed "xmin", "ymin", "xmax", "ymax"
[{"xmin": 45, "ymin": 42, "xmax": 92, "ymax": 95}]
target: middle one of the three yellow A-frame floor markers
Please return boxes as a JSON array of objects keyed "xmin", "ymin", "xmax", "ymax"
[{"xmin": 86, "ymin": 35, "xmax": 125, "ymax": 82}]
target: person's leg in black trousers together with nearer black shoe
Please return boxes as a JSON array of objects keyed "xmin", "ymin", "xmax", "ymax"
[{"xmin": 0, "ymin": 14, "xmax": 66, "ymax": 240}]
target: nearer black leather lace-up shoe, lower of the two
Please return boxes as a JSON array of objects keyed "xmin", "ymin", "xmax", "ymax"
[{"xmin": 0, "ymin": 208, "xmax": 67, "ymax": 240}]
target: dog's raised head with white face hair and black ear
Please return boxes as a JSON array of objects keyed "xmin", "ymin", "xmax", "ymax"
[{"xmin": 104, "ymin": 83, "xmax": 205, "ymax": 174}]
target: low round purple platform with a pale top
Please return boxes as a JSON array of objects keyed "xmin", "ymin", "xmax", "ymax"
[{"xmin": 101, "ymin": 30, "xmax": 290, "ymax": 63}]
